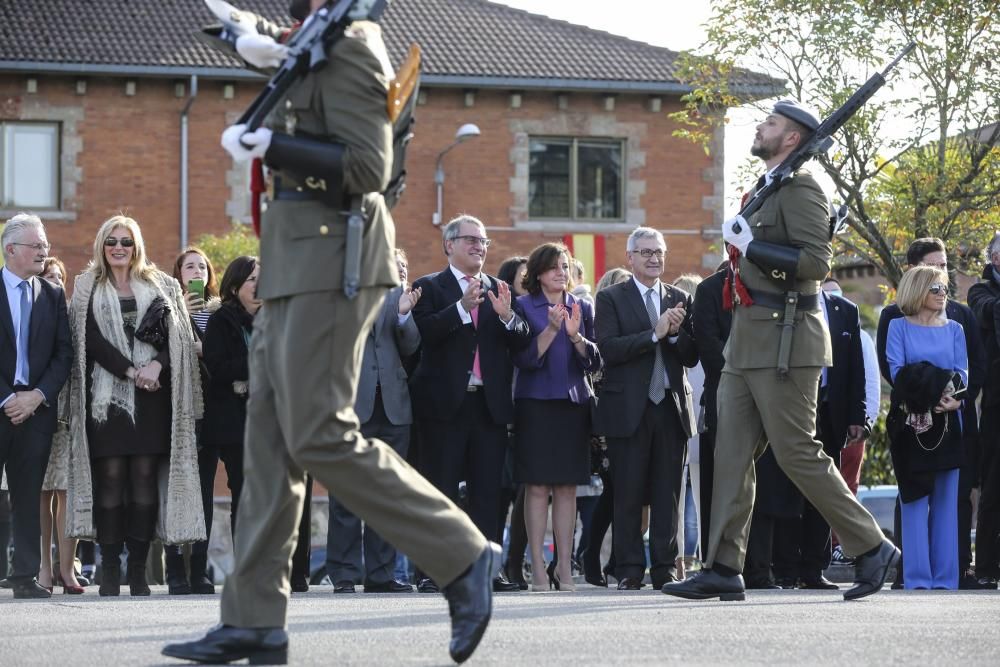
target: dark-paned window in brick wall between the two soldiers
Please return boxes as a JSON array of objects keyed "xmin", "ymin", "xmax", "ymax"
[{"xmin": 528, "ymin": 137, "xmax": 625, "ymax": 221}]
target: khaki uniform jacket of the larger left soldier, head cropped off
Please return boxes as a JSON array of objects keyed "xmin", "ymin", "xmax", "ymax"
[{"xmin": 257, "ymin": 21, "xmax": 399, "ymax": 299}]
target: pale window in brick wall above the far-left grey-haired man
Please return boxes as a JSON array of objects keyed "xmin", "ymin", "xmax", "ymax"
[{"xmin": 0, "ymin": 121, "xmax": 59, "ymax": 209}]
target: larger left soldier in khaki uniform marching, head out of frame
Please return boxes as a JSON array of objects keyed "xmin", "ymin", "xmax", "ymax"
[{"xmin": 163, "ymin": 0, "xmax": 499, "ymax": 664}]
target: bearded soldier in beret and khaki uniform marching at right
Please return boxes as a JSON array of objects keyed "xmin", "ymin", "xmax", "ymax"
[{"xmin": 663, "ymin": 100, "xmax": 899, "ymax": 600}]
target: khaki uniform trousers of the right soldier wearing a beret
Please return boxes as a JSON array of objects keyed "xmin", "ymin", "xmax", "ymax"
[{"xmin": 707, "ymin": 365, "xmax": 883, "ymax": 572}]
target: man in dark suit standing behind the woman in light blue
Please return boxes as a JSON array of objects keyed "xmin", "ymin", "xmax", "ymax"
[{"xmin": 876, "ymin": 237, "xmax": 986, "ymax": 589}]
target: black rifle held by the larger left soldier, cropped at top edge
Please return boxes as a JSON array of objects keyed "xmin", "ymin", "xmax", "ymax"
[{"xmin": 236, "ymin": 0, "xmax": 389, "ymax": 132}]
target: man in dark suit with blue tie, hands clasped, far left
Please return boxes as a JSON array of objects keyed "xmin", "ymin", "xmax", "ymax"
[{"xmin": 0, "ymin": 213, "xmax": 73, "ymax": 598}]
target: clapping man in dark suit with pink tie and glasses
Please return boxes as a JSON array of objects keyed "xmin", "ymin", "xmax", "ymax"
[{"xmin": 411, "ymin": 215, "xmax": 531, "ymax": 591}]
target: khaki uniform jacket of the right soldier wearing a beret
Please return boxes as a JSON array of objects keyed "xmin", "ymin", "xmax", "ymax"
[{"xmin": 725, "ymin": 168, "xmax": 833, "ymax": 369}]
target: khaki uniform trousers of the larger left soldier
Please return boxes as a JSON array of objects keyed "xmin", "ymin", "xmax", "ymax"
[{"xmin": 222, "ymin": 287, "xmax": 487, "ymax": 628}]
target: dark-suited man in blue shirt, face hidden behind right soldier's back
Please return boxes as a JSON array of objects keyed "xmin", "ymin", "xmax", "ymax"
[{"xmin": 774, "ymin": 282, "xmax": 869, "ymax": 590}]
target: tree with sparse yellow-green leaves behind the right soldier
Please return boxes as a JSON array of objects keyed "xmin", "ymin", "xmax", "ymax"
[{"xmin": 673, "ymin": 0, "xmax": 1000, "ymax": 285}]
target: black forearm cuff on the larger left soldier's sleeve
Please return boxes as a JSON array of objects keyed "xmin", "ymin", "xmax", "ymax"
[{"xmin": 264, "ymin": 132, "xmax": 344, "ymax": 208}]
